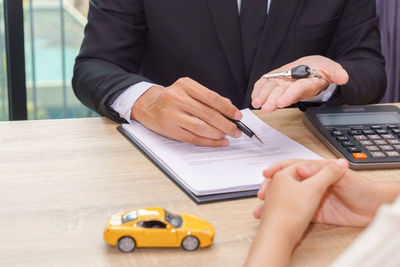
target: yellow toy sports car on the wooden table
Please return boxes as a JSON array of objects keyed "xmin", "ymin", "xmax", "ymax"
[{"xmin": 104, "ymin": 207, "xmax": 214, "ymax": 252}]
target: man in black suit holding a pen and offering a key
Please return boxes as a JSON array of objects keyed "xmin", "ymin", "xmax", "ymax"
[{"xmin": 73, "ymin": 0, "xmax": 386, "ymax": 146}]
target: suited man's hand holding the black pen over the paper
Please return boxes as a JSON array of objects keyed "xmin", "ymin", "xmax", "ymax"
[{"xmin": 131, "ymin": 78, "xmax": 242, "ymax": 147}]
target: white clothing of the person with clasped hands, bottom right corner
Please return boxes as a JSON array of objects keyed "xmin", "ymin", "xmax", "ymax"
[{"xmin": 330, "ymin": 197, "xmax": 400, "ymax": 267}]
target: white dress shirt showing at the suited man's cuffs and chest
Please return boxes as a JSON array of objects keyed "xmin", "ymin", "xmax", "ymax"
[{"xmin": 111, "ymin": 0, "xmax": 336, "ymax": 122}]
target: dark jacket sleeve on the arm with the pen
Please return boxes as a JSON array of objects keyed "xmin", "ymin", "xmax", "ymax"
[{"xmin": 72, "ymin": 0, "xmax": 151, "ymax": 122}]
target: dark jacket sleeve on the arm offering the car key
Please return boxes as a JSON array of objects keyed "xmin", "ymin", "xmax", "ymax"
[{"xmin": 328, "ymin": 0, "xmax": 386, "ymax": 105}]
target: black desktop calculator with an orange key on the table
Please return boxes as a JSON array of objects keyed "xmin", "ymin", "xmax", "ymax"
[{"xmin": 304, "ymin": 105, "xmax": 400, "ymax": 169}]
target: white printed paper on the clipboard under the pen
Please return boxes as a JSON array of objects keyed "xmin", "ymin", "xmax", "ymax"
[{"xmin": 122, "ymin": 109, "xmax": 321, "ymax": 196}]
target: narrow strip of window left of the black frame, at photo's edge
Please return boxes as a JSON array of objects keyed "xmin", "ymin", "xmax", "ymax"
[{"xmin": 0, "ymin": 0, "xmax": 8, "ymax": 121}]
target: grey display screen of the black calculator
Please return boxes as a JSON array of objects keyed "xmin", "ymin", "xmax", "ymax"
[{"xmin": 317, "ymin": 112, "xmax": 400, "ymax": 126}]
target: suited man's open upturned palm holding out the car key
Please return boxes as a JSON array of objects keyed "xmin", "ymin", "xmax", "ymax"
[{"xmin": 251, "ymin": 56, "xmax": 349, "ymax": 113}]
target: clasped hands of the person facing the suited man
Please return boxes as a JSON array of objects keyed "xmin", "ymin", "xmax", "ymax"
[{"xmin": 253, "ymin": 159, "xmax": 381, "ymax": 244}]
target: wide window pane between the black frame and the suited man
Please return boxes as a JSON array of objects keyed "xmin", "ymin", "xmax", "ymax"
[{"xmin": 23, "ymin": 0, "xmax": 97, "ymax": 119}]
